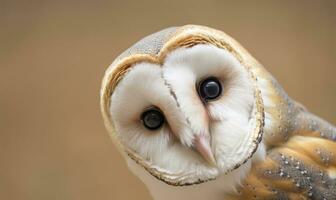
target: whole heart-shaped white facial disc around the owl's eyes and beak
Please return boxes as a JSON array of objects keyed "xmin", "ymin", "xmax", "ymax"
[{"xmin": 110, "ymin": 45, "xmax": 265, "ymax": 190}]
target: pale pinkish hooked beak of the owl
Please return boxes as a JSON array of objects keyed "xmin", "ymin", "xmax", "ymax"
[{"xmin": 194, "ymin": 134, "xmax": 216, "ymax": 166}]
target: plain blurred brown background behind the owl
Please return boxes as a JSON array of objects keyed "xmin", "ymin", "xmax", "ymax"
[{"xmin": 0, "ymin": 0, "xmax": 336, "ymax": 200}]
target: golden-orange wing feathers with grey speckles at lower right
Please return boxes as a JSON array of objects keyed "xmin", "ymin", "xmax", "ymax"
[{"xmin": 230, "ymin": 132, "xmax": 336, "ymax": 199}]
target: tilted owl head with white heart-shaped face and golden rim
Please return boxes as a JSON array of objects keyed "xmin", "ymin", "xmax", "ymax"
[{"xmin": 101, "ymin": 25, "xmax": 264, "ymax": 186}]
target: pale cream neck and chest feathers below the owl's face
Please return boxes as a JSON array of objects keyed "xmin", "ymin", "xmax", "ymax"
[{"xmin": 127, "ymin": 143, "xmax": 266, "ymax": 200}]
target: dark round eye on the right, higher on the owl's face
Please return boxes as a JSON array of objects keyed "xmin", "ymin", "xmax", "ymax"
[{"xmin": 198, "ymin": 77, "xmax": 222, "ymax": 101}]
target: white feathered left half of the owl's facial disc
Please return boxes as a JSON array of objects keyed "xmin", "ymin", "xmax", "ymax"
[{"xmin": 111, "ymin": 63, "xmax": 217, "ymax": 179}]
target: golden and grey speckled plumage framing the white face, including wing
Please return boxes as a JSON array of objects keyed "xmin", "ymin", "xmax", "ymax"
[{"xmin": 101, "ymin": 25, "xmax": 336, "ymax": 199}]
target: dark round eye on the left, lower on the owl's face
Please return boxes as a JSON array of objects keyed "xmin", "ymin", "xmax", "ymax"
[{"xmin": 141, "ymin": 108, "xmax": 164, "ymax": 130}]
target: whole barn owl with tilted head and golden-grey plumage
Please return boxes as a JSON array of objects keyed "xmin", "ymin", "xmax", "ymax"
[{"xmin": 101, "ymin": 25, "xmax": 336, "ymax": 200}]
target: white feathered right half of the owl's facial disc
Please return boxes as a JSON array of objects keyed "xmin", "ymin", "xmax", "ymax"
[{"xmin": 163, "ymin": 45, "xmax": 254, "ymax": 171}]
